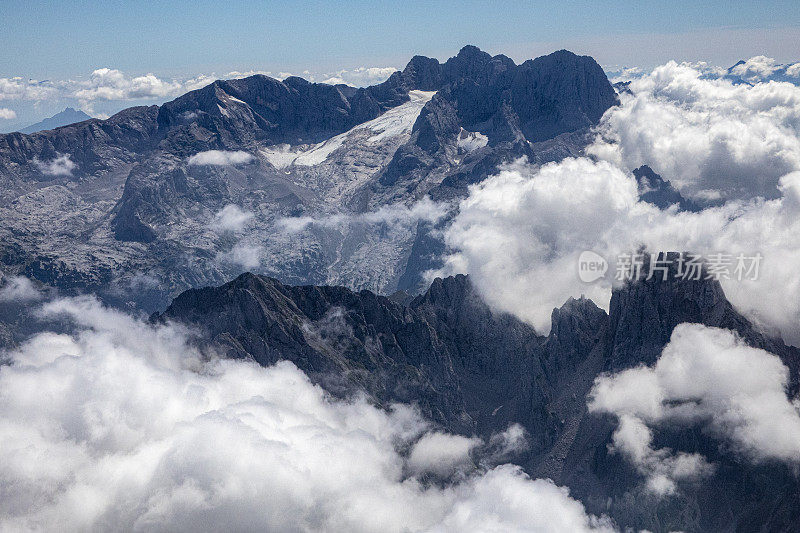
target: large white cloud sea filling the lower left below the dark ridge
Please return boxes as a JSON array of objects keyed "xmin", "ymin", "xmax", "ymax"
[{"xmin": 0, "ymin": 297, "xmax": 612, "ymax": 532}]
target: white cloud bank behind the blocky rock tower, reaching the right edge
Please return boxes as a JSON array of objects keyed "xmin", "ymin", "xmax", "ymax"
[{"xmin": 440, "ymin": 158, "xmax": 800, "ymax": 342}]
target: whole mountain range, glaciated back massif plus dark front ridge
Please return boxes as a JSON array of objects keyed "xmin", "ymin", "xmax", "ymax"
[{"xmin": 0, "ymin": 46, "xmax": 800, "ymax": 531}]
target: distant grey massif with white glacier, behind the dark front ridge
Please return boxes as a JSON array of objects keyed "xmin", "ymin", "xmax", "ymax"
[{"xmin": 0, "ymin": 46, "xmax": 617, "ymax": 312}]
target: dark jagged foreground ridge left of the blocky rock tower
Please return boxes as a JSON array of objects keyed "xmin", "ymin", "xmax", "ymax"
[{"xmin": 157, "ymin": 274, "xmax": 606, "ymax": 448}]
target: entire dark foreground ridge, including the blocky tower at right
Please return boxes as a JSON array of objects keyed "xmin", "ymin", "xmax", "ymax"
[{"xmin": 161, "ymin": 264, "xmax": 800, "ymax": 531}]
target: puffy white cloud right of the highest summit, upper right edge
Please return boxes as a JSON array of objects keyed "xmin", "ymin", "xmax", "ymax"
[{"xmin": 588, "ymin": 61, "xmax": 800, "ymax": 199}]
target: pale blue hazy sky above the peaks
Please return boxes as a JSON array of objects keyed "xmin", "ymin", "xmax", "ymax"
[{"xmin": 0, "ymin": 0, "xmax": 800, "ymax": 131}]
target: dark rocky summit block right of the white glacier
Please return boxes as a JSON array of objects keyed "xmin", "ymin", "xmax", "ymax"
[{"xmin": 380, "ymin": 46, "xmax": 618, "ymax": 194}]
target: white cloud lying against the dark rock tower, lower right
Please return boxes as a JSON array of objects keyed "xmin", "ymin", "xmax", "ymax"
[{"xmin": 589, "ymin": 324, "xmax": 800, "ymax": 494}]
